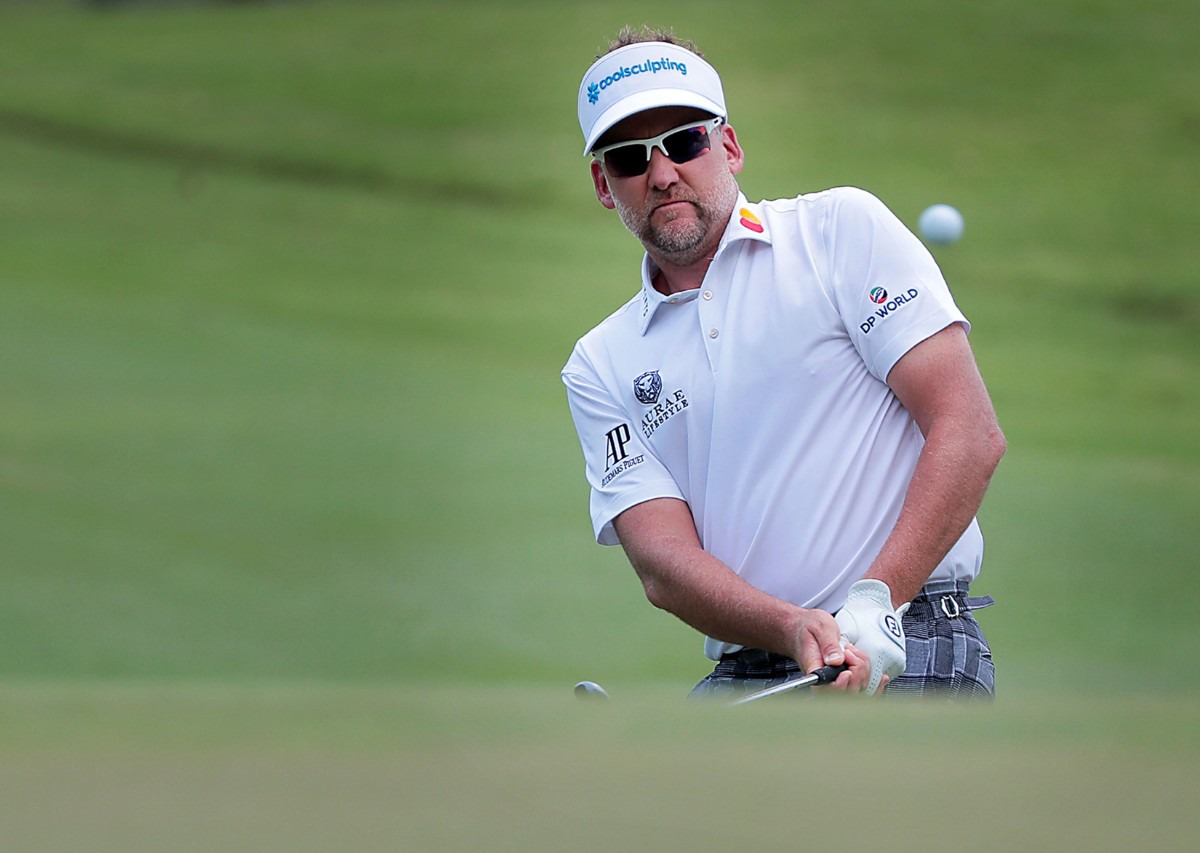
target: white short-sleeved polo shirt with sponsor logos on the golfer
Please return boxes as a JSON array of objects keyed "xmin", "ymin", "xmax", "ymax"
[{"xmin": 563, "ymin": 187, "xmax": 983, "ymax": 660}]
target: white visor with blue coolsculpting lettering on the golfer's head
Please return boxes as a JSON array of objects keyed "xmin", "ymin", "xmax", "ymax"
[{"xmin": 578, "ymin": 42, "xmax": 728, "ymax": 154}]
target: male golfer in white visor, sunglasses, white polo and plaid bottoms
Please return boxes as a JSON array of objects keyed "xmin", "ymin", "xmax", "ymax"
[{"xmin": 563, "ymin": 29, "xmax": 1006, "ymax": 696}]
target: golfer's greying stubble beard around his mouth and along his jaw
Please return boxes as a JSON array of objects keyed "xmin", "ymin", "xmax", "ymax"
[{"xmin": 613, "ymin": 173, "xmax": 738, "ymax": 266}]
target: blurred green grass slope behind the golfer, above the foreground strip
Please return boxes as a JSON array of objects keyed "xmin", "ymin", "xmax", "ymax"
[{"xmin": 0, "ymin": 0, "xmax": 1200, "ymax": 693}]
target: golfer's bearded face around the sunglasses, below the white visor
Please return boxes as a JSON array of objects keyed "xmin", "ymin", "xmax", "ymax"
[{"xmin": 592, "ymin": 107, "xmax": 743, "ymax": 266}]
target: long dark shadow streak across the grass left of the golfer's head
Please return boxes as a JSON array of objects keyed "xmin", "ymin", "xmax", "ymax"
[{"xmin": 0, "ymin": 109, "xmax": 524, "ymax": 208}]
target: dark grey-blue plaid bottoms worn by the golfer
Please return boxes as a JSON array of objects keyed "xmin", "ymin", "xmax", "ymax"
[{"xmin": 691, "ymin": 581, "xmax": 996, "ymax": 699}]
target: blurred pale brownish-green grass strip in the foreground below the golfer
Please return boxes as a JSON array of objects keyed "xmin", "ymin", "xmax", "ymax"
[{"xmin": 0, "ymin": 684, "xmax": 1200, "ymax": 851}]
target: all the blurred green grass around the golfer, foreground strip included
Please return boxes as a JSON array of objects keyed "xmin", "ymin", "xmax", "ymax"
[{"xmin": 0, "ymin": 0, "xmax": 1200, "ymax": 849}]
